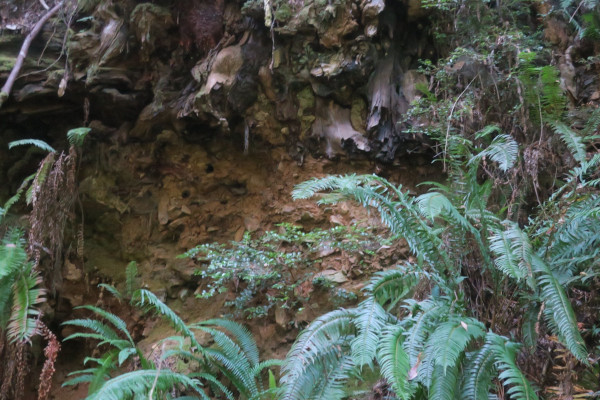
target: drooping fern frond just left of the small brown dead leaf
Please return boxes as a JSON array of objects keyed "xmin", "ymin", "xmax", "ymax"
[{"xmin": 377, "ymin": 325, "xmax": 412, "ymax": 400}]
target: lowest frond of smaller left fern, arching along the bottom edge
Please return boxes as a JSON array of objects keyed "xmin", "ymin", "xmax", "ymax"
[{"xmin": 86, "ymin": 369, "xmax": 210, "ymax": 400}]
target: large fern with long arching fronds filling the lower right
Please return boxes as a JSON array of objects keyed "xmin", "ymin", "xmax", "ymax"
[{"xmin": 281, "ymin": 127, "xmax": 600, "ymax": 400}]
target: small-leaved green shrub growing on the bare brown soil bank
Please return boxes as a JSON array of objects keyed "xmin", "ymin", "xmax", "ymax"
[{"xmin": 181, "ymin": 224, "xmax": 387, "ymax": 318}]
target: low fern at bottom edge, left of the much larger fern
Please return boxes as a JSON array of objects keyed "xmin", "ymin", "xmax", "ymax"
[{"xmin": 64, "ymin": 278, "xmax": 279, "ymax": 400}]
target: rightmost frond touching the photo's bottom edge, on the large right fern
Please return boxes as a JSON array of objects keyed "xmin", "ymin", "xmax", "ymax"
[{"xmin": 488, "ymin": 334, "xmax": 538, "ymax": 400}]
